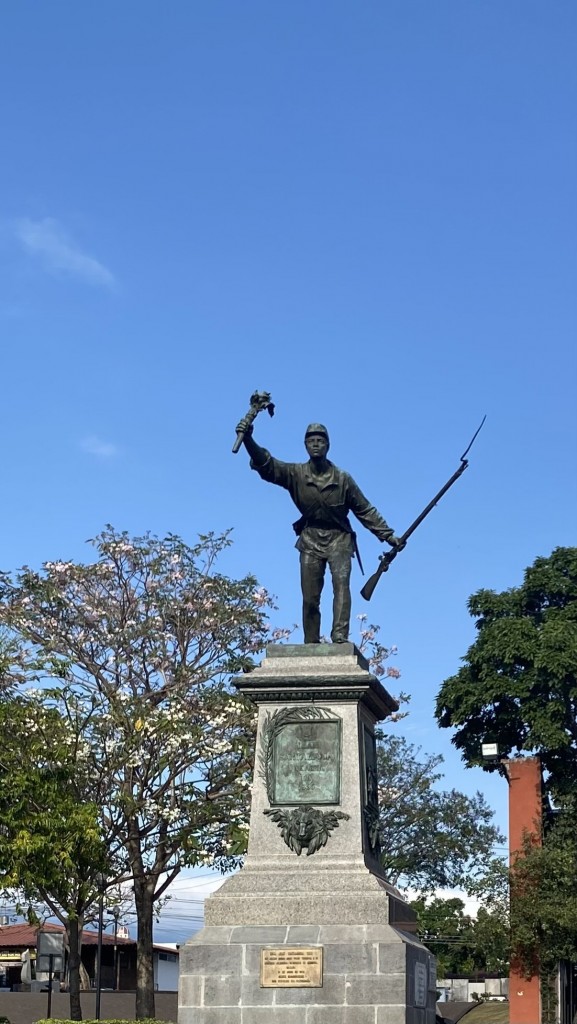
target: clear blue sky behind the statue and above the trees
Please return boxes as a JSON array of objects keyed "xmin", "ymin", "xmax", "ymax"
[{"xmin": 0, "ymin": 0, "xmax": 577, "ymax": 939}]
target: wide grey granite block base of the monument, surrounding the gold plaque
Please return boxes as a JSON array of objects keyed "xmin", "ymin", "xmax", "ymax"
[{"xmin": 178, "ymin": 921, "xmax": 436, "ymax": 1024}]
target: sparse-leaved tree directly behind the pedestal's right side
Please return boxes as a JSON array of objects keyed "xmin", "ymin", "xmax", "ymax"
[{"xmin": 377, "ymin": 733, "xmax": 503, "ymax": 892}]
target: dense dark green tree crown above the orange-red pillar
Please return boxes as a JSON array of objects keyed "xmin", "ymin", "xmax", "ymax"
[{"xmin": 437, "ymin": 548, "xmax": 577, "ymax": 801}]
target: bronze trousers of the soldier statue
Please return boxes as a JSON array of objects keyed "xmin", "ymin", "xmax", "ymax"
[{"xmin": 300, "ymin": 551, "xmax": 351, "ymax": 643}]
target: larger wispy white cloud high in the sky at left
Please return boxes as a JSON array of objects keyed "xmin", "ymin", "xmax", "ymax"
[{"xmin": 15, "ymin": 217, "xmax": 115, "ymax": 288}]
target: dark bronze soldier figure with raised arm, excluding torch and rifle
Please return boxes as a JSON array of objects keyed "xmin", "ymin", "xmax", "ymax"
[{"xmin": 237, "ymin": 417, "xmax": 405, "ymax": 643}]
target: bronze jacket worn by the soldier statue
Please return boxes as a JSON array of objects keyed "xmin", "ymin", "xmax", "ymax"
[{"xmin": 251, "ymin": 449, "xmax": 394, "ymax": 554}]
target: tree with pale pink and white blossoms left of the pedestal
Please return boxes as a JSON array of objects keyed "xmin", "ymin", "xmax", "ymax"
[{"xmin": 0, "ymin": 527, "xmax": 274, "ymax": 1018}]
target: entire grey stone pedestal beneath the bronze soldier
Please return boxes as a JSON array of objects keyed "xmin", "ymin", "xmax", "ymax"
[{"xmin": 179, "ymin": 643, "xmax": 436, "ymax": 1024}]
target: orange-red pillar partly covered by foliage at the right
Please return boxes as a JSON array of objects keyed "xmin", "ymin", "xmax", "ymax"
[{"xmin": 506, "ymin": 758, "xmax": 543, "ymax": 1024}]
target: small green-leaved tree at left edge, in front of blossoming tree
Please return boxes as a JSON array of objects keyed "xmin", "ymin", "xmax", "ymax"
[{"xmin": 0, "ymin": 694, "xmax": 112, "ymax": 1020}]
